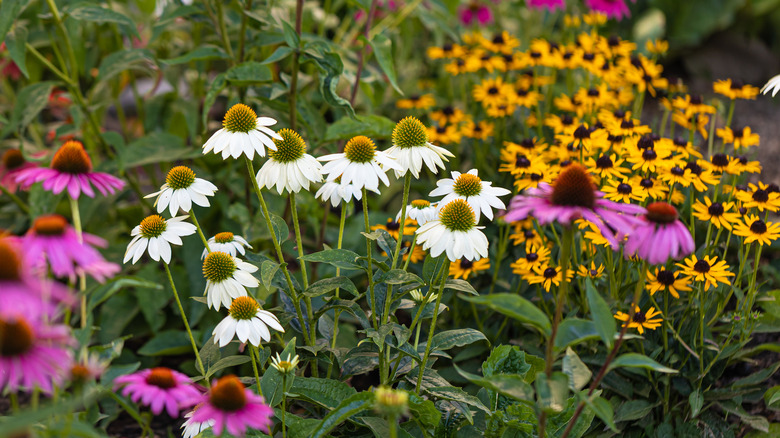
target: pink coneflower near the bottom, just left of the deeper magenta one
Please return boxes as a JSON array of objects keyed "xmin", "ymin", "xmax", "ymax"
[{"xmin": 114, "ymin": 367, "xmax": 200, "ymax": 418}]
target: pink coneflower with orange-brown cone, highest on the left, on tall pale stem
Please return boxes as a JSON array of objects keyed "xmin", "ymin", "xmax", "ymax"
[{"xmin": 16, "ymin": 141, "xmax": 125, "ymax": 199}]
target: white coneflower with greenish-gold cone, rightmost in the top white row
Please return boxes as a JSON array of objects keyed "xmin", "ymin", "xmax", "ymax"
[{"xmin": 385, "ymin": 117, "xmax": 455, "ymax": 178}]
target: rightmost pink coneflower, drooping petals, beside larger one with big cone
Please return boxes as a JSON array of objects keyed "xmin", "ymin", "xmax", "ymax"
[{"xmin": 626, "ymin": 202, "xmax": 696, "ymax": 265}]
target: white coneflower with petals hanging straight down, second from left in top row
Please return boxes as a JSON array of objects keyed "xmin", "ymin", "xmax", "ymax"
[{"xmin": 257, "ymin": 128, "xmax": 322, "ymax": 195}]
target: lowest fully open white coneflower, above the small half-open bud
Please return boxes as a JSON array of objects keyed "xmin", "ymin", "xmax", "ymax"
[{"xmin": 211, "ymin": 297, "xmax": 284, "ymax": 348}]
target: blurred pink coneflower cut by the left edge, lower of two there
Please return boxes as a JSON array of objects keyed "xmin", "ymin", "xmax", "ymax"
[{"xmin": 0, "ymin": 312, "xmax": 75, "ymax": 394}]
